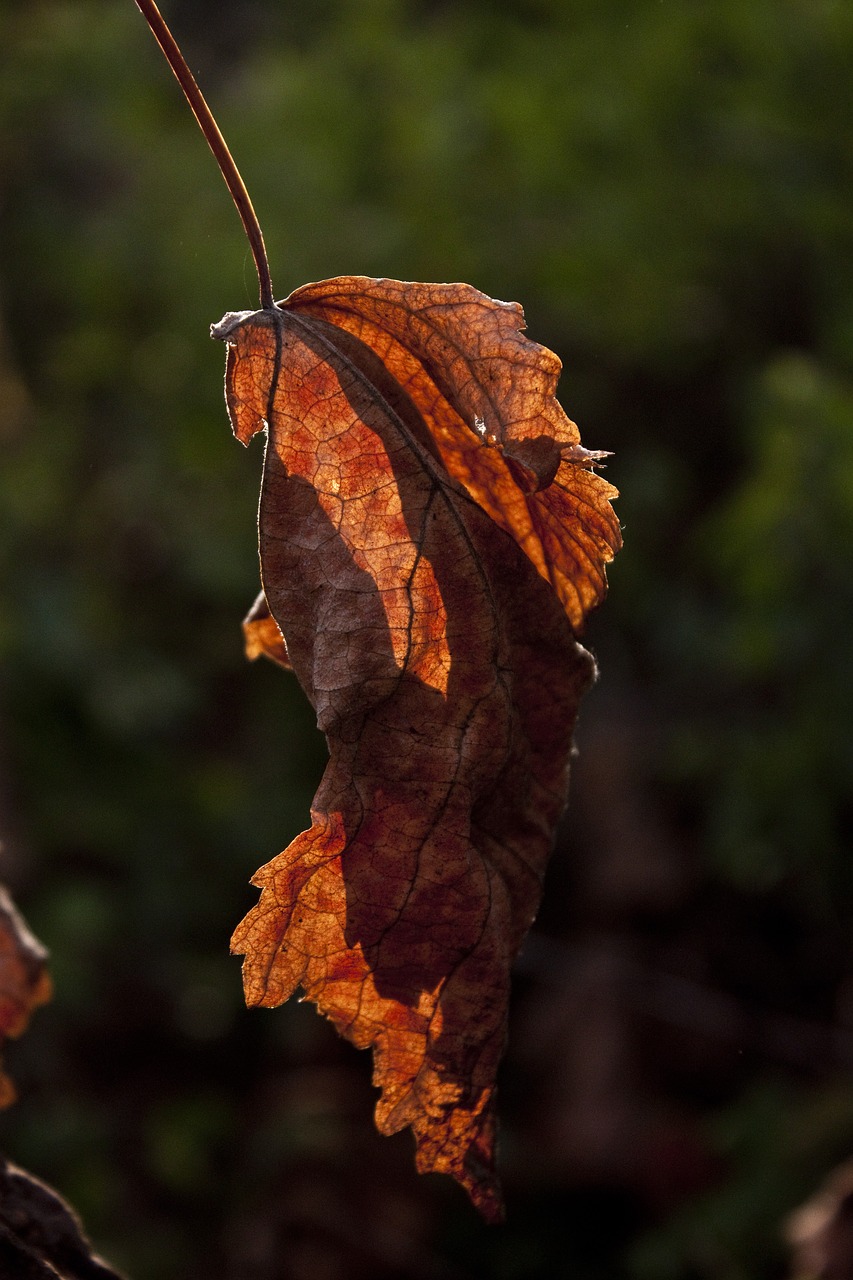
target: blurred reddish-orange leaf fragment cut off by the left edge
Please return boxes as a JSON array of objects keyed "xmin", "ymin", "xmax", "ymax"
[{"xmin": 0, "ymin": 886, "xmax": 53, "ymax": 1107}]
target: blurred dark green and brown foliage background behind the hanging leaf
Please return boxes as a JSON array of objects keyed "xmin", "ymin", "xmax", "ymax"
[{"xmin": 0, "ymin": 0, "xmax": 853, "ymax": 1280}]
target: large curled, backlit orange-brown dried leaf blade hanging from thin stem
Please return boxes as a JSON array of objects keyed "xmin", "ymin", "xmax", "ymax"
[{"xmin": 213, "ymin": 276, "xmax": 620, "ymax": 1220}]
